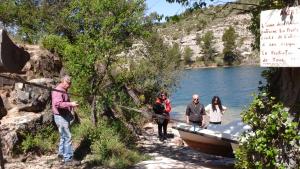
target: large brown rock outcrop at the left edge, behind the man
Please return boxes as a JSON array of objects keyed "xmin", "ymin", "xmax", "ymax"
[{"xmin": 0, "ymin": 31, "xmax": 62, "ymax": 157}]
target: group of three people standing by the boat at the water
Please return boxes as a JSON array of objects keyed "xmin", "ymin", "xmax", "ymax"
[{"xmin": 153, "ymin": 92, "xmax": 227, "ymax": 141}]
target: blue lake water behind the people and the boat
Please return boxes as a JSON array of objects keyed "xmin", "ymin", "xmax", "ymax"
[{"xmin": 170, "ymin": 67, "xmax": 265, "ymax": 124}]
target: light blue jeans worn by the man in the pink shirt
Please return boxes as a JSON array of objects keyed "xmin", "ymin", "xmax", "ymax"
[{"xmin": 54, "ymin": 115, "xmax": 73, "ymax": 161}]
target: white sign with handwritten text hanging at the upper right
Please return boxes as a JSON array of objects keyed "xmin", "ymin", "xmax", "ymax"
[{"xmin": 260, "ymin": 6, "xmax": 300, "ymax": 67}]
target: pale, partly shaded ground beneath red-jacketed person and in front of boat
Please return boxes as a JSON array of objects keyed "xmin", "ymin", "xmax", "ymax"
[{"xmin": 134, "ymin": 123, "xmax": 234, "ymax": 169}]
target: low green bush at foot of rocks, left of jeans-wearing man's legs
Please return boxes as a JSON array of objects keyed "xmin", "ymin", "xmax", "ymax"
[{"xmin": 16, "ymin": 126, "xmax": 59, "ymax": 154}]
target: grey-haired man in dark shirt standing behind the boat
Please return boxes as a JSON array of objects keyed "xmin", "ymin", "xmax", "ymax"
[{"xmin": 185, "ymin": 94, "xmax": 205, "ymax": 127}]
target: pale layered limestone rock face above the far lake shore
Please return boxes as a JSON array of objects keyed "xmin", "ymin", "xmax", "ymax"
[{"xmin": 158, "ymin": 14, "xmax": 258, "ymax": 64}]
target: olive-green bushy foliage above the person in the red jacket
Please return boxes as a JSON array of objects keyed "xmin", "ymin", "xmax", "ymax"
[{"xmin": 120, "ymin": 34, "xmax": 182, "ymax": 101}]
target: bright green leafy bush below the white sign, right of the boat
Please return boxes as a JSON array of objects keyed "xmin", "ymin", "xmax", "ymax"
[{"xmin": 236, "ymin": 93, "xmax": 300, "ymax": 169}]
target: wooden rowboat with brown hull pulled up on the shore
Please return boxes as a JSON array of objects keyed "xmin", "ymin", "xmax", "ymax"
[{"xmin": 173, "ymin": 121, "xmax": 251, "ymax": 157}]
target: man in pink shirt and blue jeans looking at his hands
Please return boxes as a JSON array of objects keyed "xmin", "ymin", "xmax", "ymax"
[{"xmin": 52, "ymin": 75, "xmax": 79, "ymax": 165}]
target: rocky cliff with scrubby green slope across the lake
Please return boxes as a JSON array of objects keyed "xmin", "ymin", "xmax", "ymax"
[{"xmin": 158, "ymin": 12, "xmax": 259, "ymax": 64}]
